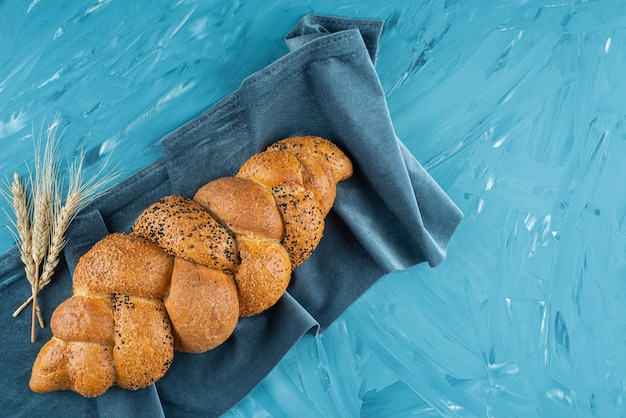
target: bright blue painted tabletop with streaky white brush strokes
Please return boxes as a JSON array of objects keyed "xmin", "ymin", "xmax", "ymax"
[{"xmin": 0, "ymin": 0, "xmax": 626, "ymax": 417}]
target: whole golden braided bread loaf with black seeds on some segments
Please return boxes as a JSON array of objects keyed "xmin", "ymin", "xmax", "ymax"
[{"xmin": 30, "ymin": 136, "xmax": 352, "ymax": 397}]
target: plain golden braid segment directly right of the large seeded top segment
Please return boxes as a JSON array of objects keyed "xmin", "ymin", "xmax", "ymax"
[{"xmin": 193, "ymin": 177, "xmax": 284, "ymax": 240}]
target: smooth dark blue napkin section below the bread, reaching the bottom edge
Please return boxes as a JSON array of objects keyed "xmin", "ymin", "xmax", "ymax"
[{"xmin": 156, "ymin": 293, "xmax": 318, "ymax": 417}]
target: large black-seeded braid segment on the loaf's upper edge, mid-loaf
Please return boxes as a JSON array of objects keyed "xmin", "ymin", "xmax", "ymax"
[{"xmin": 132, "ymin": 196, "xmax": 239, "ymax": 271}]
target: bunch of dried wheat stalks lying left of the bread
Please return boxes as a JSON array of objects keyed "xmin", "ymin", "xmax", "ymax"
[{"xmin": 2, "ymin": 115, "xmax": 120, "ymax": 342}]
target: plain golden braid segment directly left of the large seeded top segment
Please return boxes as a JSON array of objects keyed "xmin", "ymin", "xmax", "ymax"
[{"xmin": 74, "ymin": 233, "xmax": 173, "ymax": 298}]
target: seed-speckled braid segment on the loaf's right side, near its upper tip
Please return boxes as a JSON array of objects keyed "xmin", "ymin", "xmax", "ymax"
[{"xmin": 272, "ymin": 183, "xmax": 324, "ymax": 268}]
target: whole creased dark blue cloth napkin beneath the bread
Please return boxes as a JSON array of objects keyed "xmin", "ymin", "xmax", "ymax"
[{"xmin": 0, "ymin": 15, "xmax": 462, "ymax": 417}]
